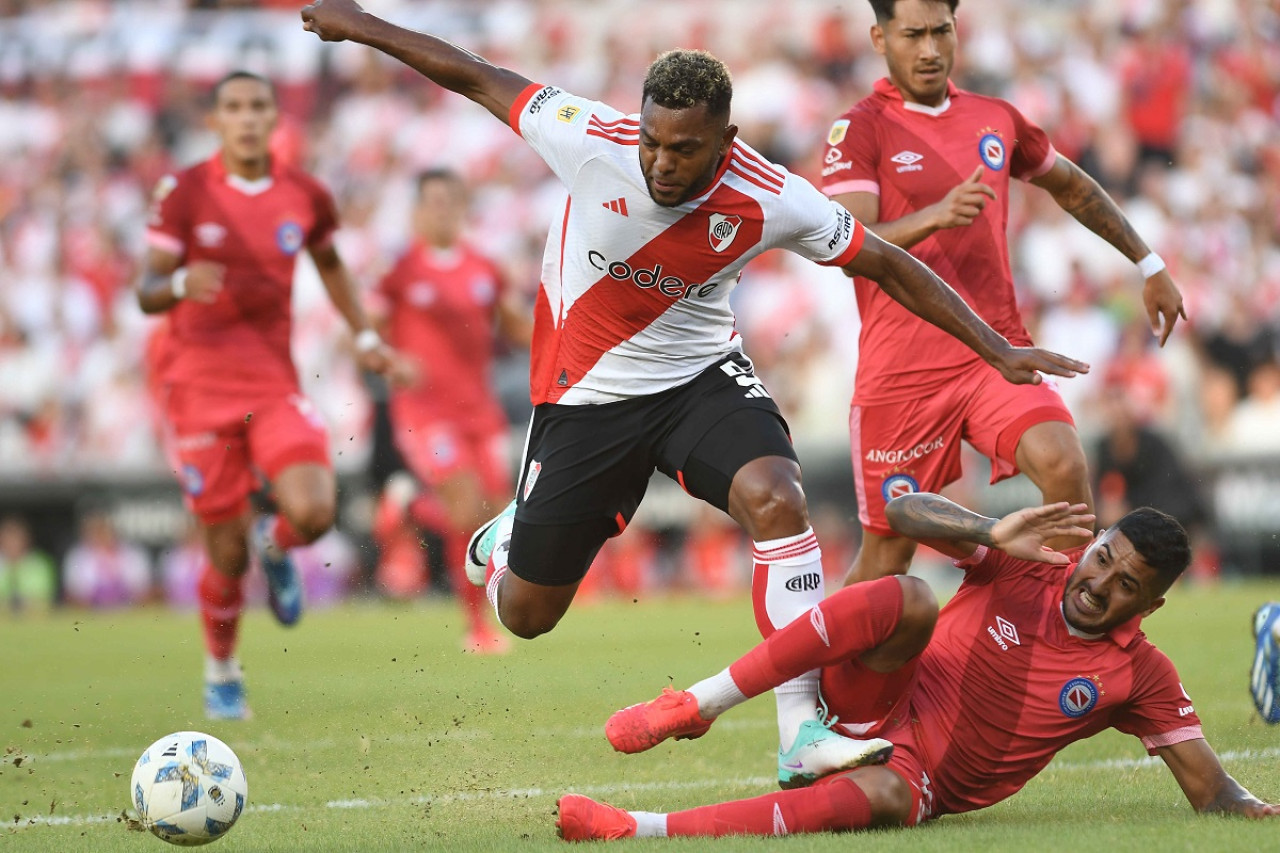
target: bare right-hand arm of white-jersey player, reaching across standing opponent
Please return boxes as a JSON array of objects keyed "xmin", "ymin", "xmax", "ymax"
[{"xmin": 844, "ymin": 232, "xmax": 1089, "ymax": 384}]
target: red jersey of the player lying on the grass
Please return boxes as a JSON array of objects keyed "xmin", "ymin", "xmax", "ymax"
[{"xmin": 911, "ymin": 547, "xmax": 1203, "ymax": 813}]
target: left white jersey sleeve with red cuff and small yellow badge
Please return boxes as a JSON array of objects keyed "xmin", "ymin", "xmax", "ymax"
[{"xmin": 511, "ymin": 83, "xmax": 626, "ymax": 187}]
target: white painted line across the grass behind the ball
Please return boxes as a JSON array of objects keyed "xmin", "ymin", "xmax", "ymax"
[{"xmin": 9, "ymin": 747, "xmax": 1280, "ymax": 829}]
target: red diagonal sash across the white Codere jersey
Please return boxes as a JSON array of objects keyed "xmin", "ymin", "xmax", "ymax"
[{"xmin": 530, "ymin": 180, "xmax": 764, "ymax": 405}]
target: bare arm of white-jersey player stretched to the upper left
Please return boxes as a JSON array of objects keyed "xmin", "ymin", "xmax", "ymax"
[{"xmin": 302, "ymin": 0, "xmax": 529, "ymax": 123}]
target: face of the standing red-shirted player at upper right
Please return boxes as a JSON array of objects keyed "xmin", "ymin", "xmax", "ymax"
[{"xmin": 872, "ymin": 0, "xmax": 956, "ymax": 106}]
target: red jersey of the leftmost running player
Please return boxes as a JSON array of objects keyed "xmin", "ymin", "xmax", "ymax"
[{"xmin": 147, "ymin": 155, "xmax": 338, "ymax": 394}]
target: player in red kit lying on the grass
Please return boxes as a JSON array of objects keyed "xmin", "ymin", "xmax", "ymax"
[{"xmin": 557, "ymin": 493, "xmax": 1280, "ymax": 840}]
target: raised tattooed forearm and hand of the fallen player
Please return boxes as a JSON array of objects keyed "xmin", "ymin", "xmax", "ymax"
[{"xmin": 884, "ymin": 492, "xmax": 1093, "ymax": 565}]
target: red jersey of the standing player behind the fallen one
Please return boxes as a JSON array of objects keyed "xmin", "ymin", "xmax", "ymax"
[{"xmin": 822, "ymin": 79, "xmax": 1057, "ymax": 405}]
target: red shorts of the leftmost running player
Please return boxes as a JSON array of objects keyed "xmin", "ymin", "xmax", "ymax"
[{"xmin": 164, "ymin": 387, "xmax": 332, "ymax": 524}]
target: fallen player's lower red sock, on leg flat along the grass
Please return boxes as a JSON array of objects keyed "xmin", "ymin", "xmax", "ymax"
[{"xmin": 667, "ymin": 775, "xmax": 872, "ymax": 838}]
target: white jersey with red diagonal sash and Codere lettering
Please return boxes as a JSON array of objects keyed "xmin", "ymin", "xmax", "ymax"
[{"xmin": 509, "ymin": 83, "xmax": 864, "ymax": 405}]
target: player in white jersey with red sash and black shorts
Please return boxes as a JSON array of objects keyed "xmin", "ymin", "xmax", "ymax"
[{"xmin": 302, "ymin": 0, "xmax": 1087, "ymax": 784}]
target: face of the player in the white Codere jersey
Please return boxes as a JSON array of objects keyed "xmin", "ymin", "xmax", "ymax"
[{"xmin": 640, "ymin": 100, "xmax": 737, "ymax": 207}]
